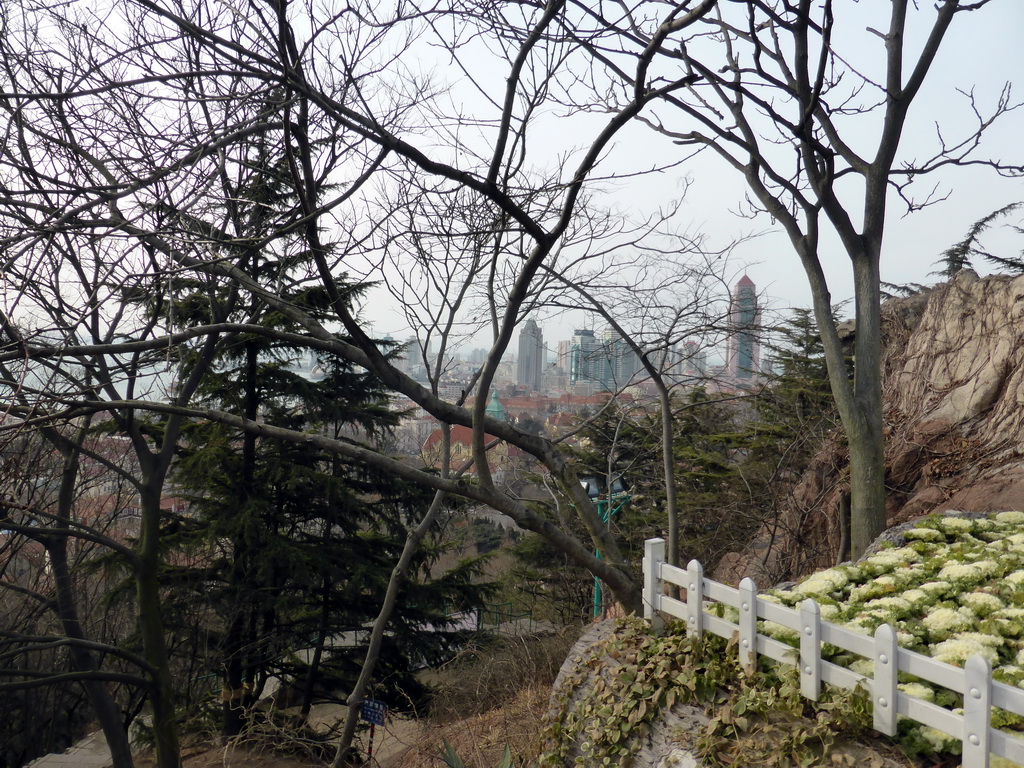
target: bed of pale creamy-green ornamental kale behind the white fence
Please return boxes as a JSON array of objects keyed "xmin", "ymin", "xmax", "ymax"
[{"xmin": 761, "ymin": 512, "xmax": 1024, "ymax": 752}]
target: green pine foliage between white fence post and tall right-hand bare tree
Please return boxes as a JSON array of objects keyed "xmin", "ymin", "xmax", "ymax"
[{"xmin": 561, "ymin": 309, "xmax": 852, "ymax": 566}]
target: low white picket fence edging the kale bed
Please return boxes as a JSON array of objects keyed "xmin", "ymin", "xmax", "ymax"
[{"xmin": 643, "ymin": 539, "xmax": 1024, "ymax": 768}]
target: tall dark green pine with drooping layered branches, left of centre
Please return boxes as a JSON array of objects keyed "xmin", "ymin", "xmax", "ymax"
[{"xmin": 155, "ymin": 129, "xmax": 483, "ymax": 735}]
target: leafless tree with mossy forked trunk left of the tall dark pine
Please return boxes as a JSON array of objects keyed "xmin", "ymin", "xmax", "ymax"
[{"xmin": 0, "ymin": 6, "xmax": 260, "ymax": 766}]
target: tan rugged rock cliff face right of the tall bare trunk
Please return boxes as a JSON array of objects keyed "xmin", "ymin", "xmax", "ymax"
[{"xmin": 886, "ymin": 271, "xmax": 1024, "ymax": 521}]
